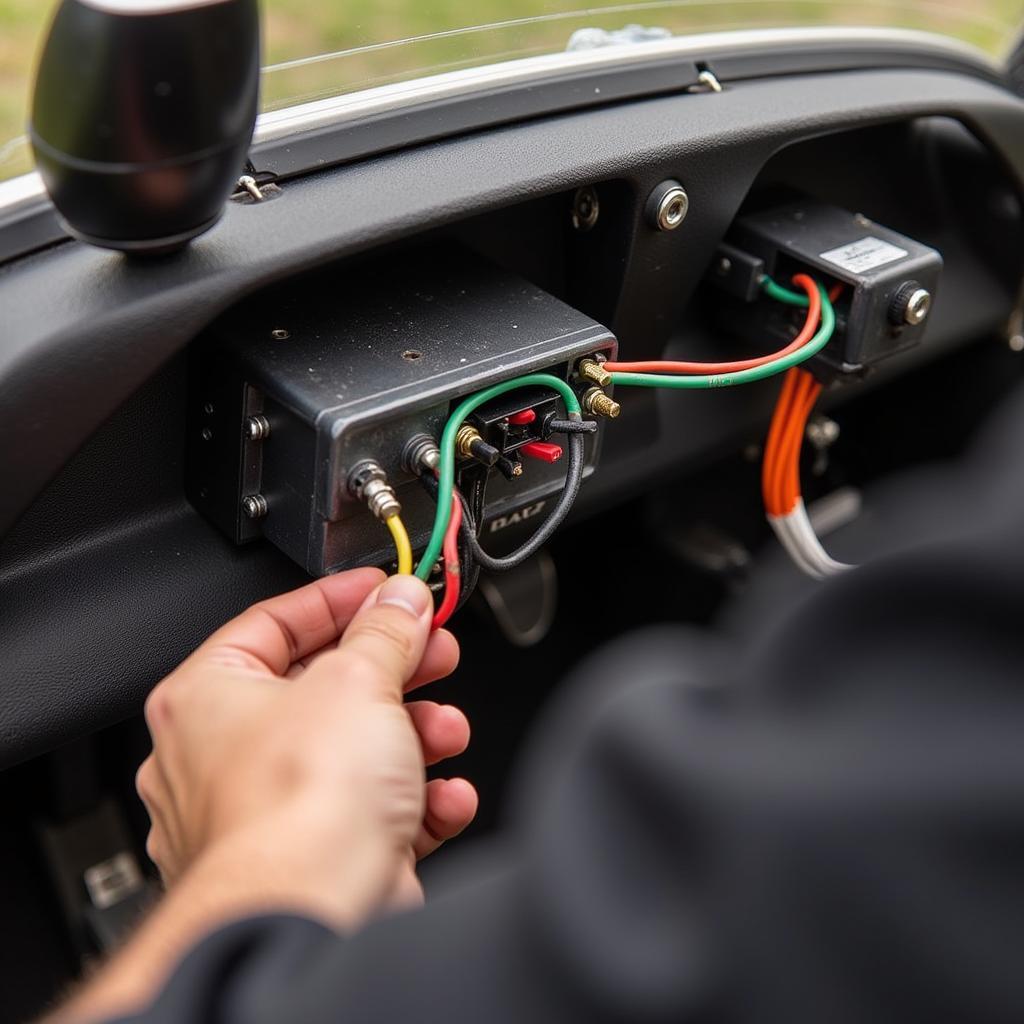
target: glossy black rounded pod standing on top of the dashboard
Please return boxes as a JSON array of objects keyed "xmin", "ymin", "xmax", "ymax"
[{"xmin": 30, "ymin": 0, "xmax": 259, "ymax": 253}]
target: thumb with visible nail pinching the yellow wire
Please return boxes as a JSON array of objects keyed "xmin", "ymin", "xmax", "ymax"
[{"xmin": 307, "ymin": 575, "xmax": 434, "ymax": 703}]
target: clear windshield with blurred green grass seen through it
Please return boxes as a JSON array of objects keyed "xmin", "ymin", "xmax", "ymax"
[{"xmin": 0, "ymin": 0, "xmax": 1024, "ymax": 179}]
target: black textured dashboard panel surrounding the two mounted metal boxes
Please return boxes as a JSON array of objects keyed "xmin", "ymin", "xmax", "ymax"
[{"xmin": 0, "ymin": 59, "xmax": 1024, "ymax": 764}]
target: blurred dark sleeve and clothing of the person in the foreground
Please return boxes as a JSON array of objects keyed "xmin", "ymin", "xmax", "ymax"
[{"xmin": 116, "ymin": 537, "xmax": 1024, "ymax": 1024}]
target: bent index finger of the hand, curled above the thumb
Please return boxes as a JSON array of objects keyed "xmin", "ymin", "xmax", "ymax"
[{"xmin": 189, "ymin": 568, "xmax": 384, "ymax": 676}]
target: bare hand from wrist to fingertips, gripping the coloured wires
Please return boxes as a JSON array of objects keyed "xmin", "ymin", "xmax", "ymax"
[{"xmin": 137, "ymin": 569, "xmax": 477, "ymax": 927}]
